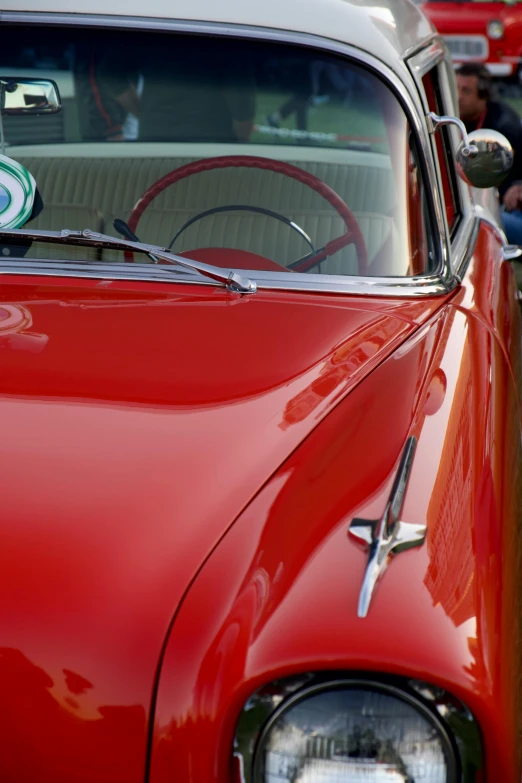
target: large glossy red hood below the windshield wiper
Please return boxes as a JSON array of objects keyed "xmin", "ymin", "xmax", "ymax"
[{"xmin": 0, "ymin": 278, "xmax": 442, "ymax": 783}]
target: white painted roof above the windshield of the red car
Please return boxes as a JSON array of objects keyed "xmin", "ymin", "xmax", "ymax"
[{"xmin": 0, "ymin": 0, "xmax": 434, "ymax": 70}]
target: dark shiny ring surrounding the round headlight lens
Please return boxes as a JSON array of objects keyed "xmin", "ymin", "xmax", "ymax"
[{"xmin": 232, "ymin": 670, "xmax": 483, "ymax": 783}]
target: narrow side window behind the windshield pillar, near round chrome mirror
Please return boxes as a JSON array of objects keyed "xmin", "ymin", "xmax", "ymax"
[{"xmin": 422, "ymin": 67, "xmax": 462, "ymax": 236}]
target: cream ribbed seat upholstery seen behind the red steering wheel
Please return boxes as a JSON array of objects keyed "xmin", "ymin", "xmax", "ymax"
[{"xmin": 16, "ymin": 157, "xmax": 394, "ymax": 274}]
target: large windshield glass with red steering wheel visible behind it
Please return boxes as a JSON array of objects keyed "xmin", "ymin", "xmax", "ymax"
[{"xmin": 0, "ymin": 25, "xmax": 433, "ymax": 276}]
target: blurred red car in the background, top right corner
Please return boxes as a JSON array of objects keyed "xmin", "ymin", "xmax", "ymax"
[{"xmin": 422, "ymin": 0, "xmax": 522, "ymax": 78}]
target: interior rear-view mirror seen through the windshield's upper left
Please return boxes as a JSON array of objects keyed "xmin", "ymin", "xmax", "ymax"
[{"xmin": 0, "ymin": 76, "xmax": 62, "ymax": 115}]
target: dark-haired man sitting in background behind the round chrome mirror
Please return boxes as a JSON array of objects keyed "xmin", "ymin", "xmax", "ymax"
[{"xmin": 457, "ymin": 63, "xmax": 522, "ymax": 245}]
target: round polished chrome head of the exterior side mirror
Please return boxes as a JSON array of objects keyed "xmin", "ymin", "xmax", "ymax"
[{"xmin": 456, "ymin": 128, "xmax": 513, "ymax": 188}]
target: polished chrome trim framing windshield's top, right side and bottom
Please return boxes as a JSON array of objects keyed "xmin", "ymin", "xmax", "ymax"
[{"xmin": 0, "ymin": 11, "xmax": 452, "ymax": 297}]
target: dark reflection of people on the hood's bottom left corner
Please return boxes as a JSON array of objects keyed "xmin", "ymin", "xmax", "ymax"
[{"xmin": 0, "ymin": 647, "xmax": 146, "ymax": 783}]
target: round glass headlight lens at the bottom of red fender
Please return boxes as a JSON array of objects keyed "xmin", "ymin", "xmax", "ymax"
[{"xmin": 238, "ymin": 680, "xmax": 457, "ymax": 783}]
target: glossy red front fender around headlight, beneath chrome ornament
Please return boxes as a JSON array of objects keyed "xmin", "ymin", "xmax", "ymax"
[{"xmin": 146, "ymin": 227, "xmax": 522, "ymax": 783}]
